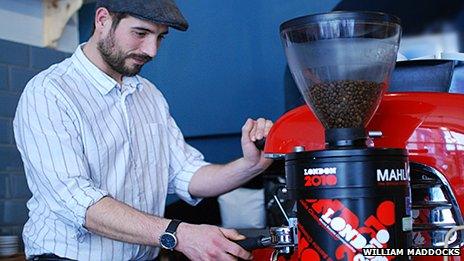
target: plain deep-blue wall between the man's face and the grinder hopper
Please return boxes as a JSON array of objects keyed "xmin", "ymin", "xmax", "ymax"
[{"xmin": 152, "ymin": 0, "xmax": 338, "ymax": 136}]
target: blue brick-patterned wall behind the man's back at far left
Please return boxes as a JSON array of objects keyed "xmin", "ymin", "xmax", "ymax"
[{"xmin": 0, "ymin": 40, "xmax": 69, "ymax": 238}]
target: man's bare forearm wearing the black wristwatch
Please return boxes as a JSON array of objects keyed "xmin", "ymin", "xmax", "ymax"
[{"xmin": 85, "ymin": 197, "xmax": 169, "ymax": 246}]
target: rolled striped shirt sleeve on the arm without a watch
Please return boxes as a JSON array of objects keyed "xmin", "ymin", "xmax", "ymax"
[{"xmin": 161, "ymin": 104, "xmax": 210, "ymax": 205}]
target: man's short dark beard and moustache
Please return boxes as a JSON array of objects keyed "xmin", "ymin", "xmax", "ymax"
[{"xmin": 97, "ymin": 32, "xmax": 152, "ymax": 77}]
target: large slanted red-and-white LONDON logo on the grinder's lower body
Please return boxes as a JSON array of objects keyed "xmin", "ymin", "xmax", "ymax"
[{"xmin": 300, "ymin": 199, "xmax": 396, "ymax": 261}]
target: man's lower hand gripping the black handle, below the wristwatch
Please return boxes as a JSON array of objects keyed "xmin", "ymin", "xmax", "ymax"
[{"xmin": 176, "ymin": 223, "xmax": 252, "ymax": 260}]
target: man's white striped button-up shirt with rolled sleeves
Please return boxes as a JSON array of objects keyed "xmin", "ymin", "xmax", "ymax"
[{"xmin": 14, "ymin": 45, "xmax": 208, "ymax": 260}]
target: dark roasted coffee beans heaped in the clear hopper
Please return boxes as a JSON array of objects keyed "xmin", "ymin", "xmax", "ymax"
[{"xmin": 308, "ymin": 80, "xmax": 385, "ymax": 129}]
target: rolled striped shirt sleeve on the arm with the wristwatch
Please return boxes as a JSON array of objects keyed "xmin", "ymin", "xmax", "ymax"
[{"xmin": 14, "ymin": 77, "xmax": 108, "ymax": 239}]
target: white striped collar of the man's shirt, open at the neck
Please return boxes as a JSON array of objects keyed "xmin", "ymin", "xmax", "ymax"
[{"xmin": 72, "ymin": 43, "xmax": 143, "ymax": 95}]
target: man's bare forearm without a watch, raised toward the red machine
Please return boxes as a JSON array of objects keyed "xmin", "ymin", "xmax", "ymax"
[{"xmin": 189, "ymin": 158, "xmax": 263, "ymax": 197}]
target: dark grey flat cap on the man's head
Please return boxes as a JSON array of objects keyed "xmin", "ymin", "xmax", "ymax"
[{"xmin": 96, "ymin": 0, "xmax": 188, "ymax": 31}]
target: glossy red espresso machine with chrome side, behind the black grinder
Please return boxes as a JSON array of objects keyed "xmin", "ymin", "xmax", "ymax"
[{"xmin": 254, "ymin": 92, "xmax": 464, "ymax": 261}]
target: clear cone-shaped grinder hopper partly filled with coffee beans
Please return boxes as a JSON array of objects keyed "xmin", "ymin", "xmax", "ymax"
[{"xmin": 280, "ymin": 12, "xmax": 401, "ymax": 148}]
